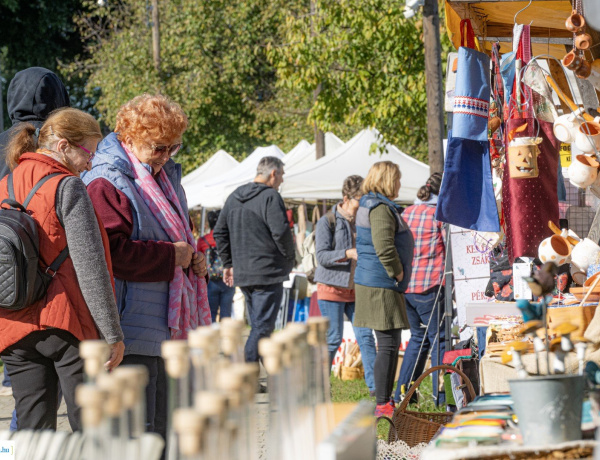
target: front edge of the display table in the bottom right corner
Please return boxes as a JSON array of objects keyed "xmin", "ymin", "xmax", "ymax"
[{"xmin": 421, "ymin": 441, "xmax": 597, "ymax": 460}]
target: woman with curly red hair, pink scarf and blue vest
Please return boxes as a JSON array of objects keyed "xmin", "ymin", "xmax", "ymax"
[{"xmin": 83, "ymin": 94, "xmax": 211, "ymax": 450}]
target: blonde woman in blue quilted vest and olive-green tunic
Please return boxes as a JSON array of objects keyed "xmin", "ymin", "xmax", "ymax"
[{"xmin": 354, "ymin": 161, "xmax": 414, "ymax": 417}]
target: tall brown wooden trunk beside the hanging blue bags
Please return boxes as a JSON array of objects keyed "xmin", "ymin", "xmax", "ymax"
[{"xmin": 423, "ymin": 0, "xmax": 445, "ymax": 174}]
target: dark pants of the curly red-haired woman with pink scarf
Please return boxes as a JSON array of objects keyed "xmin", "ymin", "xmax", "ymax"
[{"xmin": 121, "ymin": 355, "xmax": 168, "ymax": 458}]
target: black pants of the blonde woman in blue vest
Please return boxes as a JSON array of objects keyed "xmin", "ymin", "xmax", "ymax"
[{"xmin": 374, "ymin": 329, "xmax": 402, "ymax": 404}]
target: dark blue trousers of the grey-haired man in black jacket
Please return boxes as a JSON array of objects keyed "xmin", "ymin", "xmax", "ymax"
[{"xmin": 241, "ymin": 283, "xmax": 283, "ymax": 362}]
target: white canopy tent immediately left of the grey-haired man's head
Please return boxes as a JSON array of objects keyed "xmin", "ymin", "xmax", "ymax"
[{"xmin": 183, "ymin": 145, "xmax": 285, "ymax": 209}]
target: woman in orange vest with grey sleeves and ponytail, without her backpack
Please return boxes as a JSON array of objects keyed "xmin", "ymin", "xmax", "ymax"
[{"xmin": 0, "ymin": 108, "xmax": 124, "ymax": 431}]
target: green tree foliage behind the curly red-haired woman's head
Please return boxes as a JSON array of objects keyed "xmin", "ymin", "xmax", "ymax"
[{"xmin": 69, "ymin": 0, "xmax": 312, "ymax": 171}]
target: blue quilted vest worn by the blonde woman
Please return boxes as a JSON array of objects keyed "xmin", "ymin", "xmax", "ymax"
[{"xmin": 354, "ymin": 192, "xmax": 415, "ymax": 292}]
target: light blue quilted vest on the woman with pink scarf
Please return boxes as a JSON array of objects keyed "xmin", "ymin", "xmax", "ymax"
[{"xmin": 82, "ymin": 133, "xmax": 188, "ymax": 356}]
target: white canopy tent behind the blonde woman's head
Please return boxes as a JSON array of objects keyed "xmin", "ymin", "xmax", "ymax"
[{"xmin": 281, "ymin": 129, "xmax": 429, "ymax": 203}]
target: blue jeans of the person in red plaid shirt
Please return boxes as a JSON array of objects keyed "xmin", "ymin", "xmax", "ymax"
[{"xmin": 395, "ymin": 288, "xmax": 446, "ymax": 405}]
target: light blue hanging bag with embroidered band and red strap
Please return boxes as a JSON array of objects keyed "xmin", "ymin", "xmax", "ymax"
[{"xmin": 452, "ymin": 19, "xmax": 490, "ymax": 142}]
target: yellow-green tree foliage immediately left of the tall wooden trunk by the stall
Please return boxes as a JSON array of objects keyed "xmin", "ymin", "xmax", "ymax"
[{"xmin": 269, "ymin": 0, "xmax": 448, "ymax": 161}]
